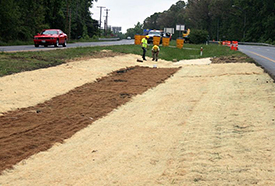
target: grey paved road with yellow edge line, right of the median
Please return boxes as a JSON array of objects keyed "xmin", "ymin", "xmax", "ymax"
[{"xmin": 239, "ymin": 45, "xmax": 275, "ymax": 77}]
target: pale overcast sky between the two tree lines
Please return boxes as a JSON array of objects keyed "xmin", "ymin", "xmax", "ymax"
[{"xmin": 91, "ymin": 0, "xmax": 183, "ymax": 33}]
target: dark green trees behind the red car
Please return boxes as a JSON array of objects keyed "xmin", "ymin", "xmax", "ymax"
[{"xmin": 0, "ymin": 0, "xmax": 99, "ymax": 42}]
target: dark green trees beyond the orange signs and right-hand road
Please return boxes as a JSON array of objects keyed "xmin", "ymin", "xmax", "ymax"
[{"xmin": 127, "ymin": 0, "xmax": 275, "ymax": 44}]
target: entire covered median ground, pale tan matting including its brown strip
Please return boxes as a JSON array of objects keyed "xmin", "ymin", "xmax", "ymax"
[{"xmin": 0, "ymin": 55, "xmax": 275, "ymax": 186}]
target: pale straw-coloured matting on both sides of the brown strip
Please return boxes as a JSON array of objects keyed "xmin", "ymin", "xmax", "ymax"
[{"xmin": 0, "ymin": 55, "xmax": 275, "ymax": 186}]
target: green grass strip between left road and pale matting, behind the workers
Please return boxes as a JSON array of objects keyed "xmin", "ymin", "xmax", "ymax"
[{"xmin": 0, "ymin": 43, "xmax": 244, "ymax": 77}]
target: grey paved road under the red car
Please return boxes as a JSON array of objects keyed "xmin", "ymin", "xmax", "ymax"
[{"xmin": 0, "ymin": 39, "xmax": 134, "ymax": 52}]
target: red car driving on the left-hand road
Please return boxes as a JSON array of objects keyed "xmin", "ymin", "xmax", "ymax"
[{"xmin": 33, "ymin": 29, "xmax": 67, "ymax": 47}]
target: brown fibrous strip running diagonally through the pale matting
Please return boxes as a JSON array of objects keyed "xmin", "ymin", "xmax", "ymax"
[{"xmin": 0, "ymin": 66, "xmax": 178, "ymax": 174}]
